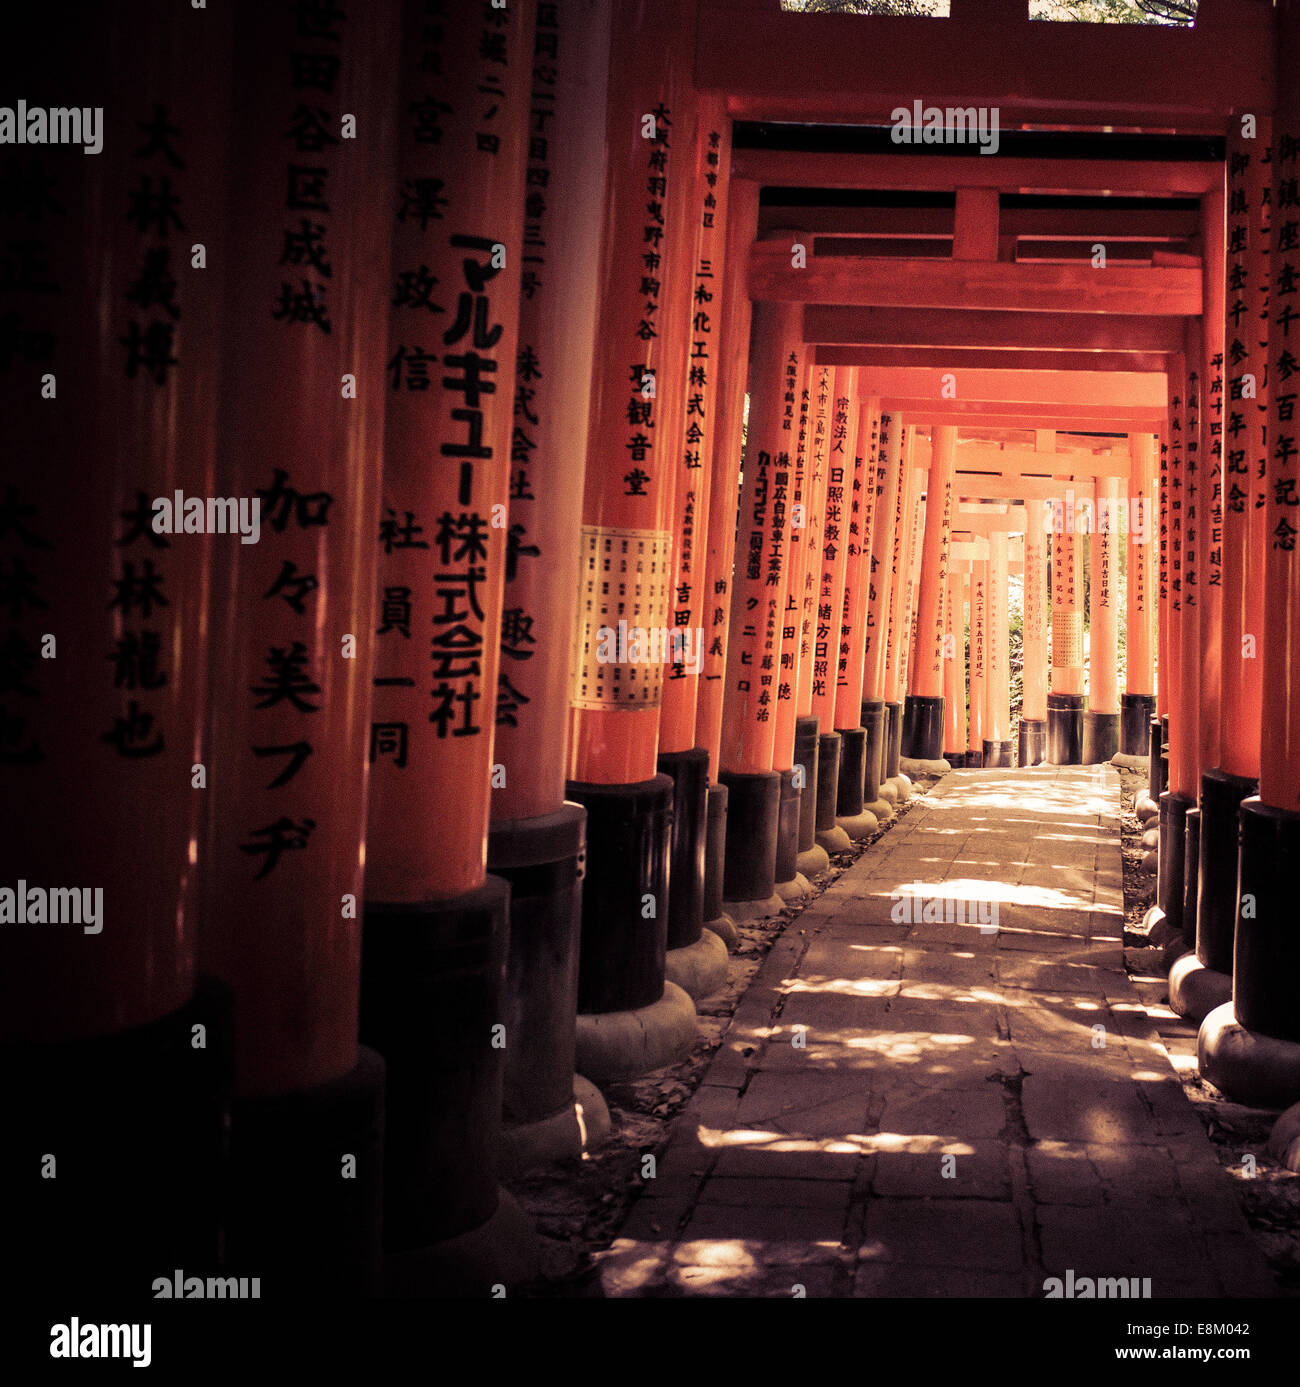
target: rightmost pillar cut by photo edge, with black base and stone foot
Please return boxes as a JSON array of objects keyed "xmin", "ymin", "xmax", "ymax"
[{"xmin": 1197, "ymin": 3, "xmax": 1300, "ymax": 1107}]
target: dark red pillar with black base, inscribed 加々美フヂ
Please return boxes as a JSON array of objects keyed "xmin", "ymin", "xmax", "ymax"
[{"xmin": 200, "ymin": 7, "xmax": 399, "ymax": 1287}]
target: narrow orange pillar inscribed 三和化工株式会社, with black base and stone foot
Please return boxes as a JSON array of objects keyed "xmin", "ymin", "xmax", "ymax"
[{"xmin": 658, "ymin": 93, "xmax": 731, "ymax": 997}]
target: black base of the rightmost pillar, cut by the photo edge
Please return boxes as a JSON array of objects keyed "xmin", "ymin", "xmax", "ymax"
[{"xmin": 1232, "ymin": 795, "xmax": 1300, "ymax": 1042}]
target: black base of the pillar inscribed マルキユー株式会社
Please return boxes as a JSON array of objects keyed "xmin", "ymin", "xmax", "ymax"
[{"xmin": 361, "ymin": 877, "xmax": 510, "ymax": 1252}]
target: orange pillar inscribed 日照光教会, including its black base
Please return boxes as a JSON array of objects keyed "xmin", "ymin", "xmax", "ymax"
[{"xmin": 809, "ymin": 366, "xmax": 857, "ymax": 853}]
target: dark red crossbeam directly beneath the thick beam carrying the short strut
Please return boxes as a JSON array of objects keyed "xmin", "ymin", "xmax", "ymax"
[{"xmin": 803, "ymin": 307, "xmax": 1185, "ymax": 352}]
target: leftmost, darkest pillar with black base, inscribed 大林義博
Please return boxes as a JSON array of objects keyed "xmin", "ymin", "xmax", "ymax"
[{"xmin": 0, "ymin": 3, "xmax": 230, "ymax": 1304}]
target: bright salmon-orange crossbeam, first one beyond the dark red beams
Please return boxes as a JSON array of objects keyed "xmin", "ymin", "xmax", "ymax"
[{"xmin": 859, "ymin": 366, "xmax": 1168, "ymax": 409}]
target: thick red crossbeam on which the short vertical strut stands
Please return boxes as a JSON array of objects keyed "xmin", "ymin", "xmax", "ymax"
[{"xmin": 748, "ymin": 241, "xmax": 1201, "ymax": 318}]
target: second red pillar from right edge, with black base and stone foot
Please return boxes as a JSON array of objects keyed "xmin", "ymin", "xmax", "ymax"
[{"xmin": 1170, "ymin": 118, "xmax": 1271, "ymax": 1019}]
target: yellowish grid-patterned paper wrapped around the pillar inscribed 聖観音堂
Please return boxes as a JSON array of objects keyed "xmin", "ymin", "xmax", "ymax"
[{"xmin": 572, "ymin": 526, "xmax": 668, "ymax": 709}]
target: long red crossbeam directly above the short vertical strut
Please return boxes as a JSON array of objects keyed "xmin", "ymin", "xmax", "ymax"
[{"xmin": 731, "ymin": 146, "xmax": 1224, "ymax": 197}]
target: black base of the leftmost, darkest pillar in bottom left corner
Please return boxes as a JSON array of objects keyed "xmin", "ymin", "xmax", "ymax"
[{"xmin": 0, "ymin": 976, "xmax": 230, "ymax": 1304}]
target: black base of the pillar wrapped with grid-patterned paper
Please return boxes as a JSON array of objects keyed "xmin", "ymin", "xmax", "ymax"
[{"xmin": 566, "ymin": 775, "xmax": 673, "ymax": 1014}]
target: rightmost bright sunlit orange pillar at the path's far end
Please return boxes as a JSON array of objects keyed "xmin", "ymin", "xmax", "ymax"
[{"xmin": 1120, "ymin": 433, "xmax": 1158, "ymax": 756}]
